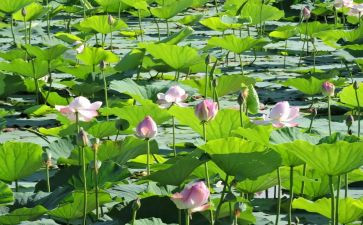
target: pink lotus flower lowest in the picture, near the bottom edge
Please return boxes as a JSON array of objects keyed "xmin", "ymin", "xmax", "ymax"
[{"xmin": 171, "ymin": 181, "xmax": 210, "ymax": 213}]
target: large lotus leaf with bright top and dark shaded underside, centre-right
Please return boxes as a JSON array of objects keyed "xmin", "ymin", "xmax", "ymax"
[{"xmin": 199, "ymin": 137, "xmax": 281, "ymax": 180}]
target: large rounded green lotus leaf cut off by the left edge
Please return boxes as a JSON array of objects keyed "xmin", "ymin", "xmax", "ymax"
[{"xmin": 0, "ymin": 142, "xmax": 43, "ymax": 181}]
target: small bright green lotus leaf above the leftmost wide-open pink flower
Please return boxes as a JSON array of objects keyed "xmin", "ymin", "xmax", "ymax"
[{"xmin": 77, "ymin": 47, "xmax": 119, "ymax": 66}]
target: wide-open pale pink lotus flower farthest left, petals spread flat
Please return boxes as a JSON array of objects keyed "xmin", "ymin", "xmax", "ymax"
[{"xmin": 55, "ymin": 96, "xmax": 102, "ymax": 122}]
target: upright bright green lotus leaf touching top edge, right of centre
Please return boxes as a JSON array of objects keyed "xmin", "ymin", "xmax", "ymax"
[{"xmin": 241, "ymin": 1, "xmax": 284, "ymax": 25}]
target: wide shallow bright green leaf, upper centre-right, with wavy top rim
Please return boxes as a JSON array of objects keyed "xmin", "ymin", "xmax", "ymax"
[{"xmin": 208, "ymin": 35, "xmax": 268, "ymax": 54}]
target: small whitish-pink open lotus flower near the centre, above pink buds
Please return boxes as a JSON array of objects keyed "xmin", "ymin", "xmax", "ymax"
[{"xmin": 157, "ymin": 85, "xmax": 188, "ymax": 108}]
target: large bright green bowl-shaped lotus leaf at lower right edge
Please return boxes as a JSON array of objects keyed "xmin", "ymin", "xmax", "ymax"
[{"xmin": 288, "ymin": 141, "xmax": 363, "ymax": 176}]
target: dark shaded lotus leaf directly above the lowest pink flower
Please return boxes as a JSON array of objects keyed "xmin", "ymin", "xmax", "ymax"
[{"xmin": 145, "ymin": 151, "xmax": 205, "ymax": 186}]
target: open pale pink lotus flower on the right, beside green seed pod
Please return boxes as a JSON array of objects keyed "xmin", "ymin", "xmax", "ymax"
[{"xmin": 254, "ymin": 101, "xmax": 300, "ymax": 128}]
